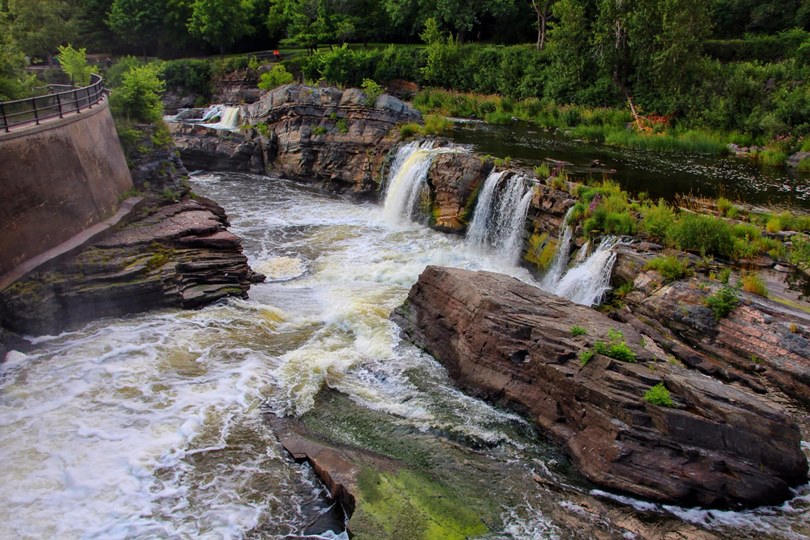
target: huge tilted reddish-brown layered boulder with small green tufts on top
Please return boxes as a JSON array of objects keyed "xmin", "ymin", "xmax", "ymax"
[{"xmin": 393, "ymin": 267, "xmax": 807, "ymax": 507}]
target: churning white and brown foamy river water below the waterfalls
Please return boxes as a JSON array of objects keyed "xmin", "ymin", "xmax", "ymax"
[{"xmin": 0, "ymin": 174, "xmax": 810, "ymax": 539}]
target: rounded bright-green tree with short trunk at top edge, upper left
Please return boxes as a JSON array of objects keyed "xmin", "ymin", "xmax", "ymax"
[{"xmin": 188, "ymin": 0, "xmax": 255, "ymax": 56}]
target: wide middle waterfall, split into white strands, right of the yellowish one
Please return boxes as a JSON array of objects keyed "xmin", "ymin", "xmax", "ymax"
[{"xmin": 467, "ymin": 172, "xmax": 533, "ymax": 263}]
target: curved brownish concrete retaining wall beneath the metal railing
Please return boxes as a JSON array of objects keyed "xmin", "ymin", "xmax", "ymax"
[{"xmin": 0, "ymin": 101, "xmax": 132, "ymax": 275}]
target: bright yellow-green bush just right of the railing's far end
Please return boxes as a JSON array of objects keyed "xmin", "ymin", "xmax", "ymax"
[{"xmin": 110, "ymin": 64, "xmax": 165, "ymax": 123}]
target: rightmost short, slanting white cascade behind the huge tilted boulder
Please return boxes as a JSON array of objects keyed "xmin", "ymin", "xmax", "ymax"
[{"xmin": 554, "ymin": 236, "xmax": 619, "ymax": 306}]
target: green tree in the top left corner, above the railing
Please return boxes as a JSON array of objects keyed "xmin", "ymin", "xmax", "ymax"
[{"xmin": 8, "ymin": 0, "xmax": 77, "ymax": 60}]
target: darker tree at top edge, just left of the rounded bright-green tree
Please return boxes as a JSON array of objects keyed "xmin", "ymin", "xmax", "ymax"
[{"xmin": 107, "ymin": 0, "xmax": 165, "ymax": 60}]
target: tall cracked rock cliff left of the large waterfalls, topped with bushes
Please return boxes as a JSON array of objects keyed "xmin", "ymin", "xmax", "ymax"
[{"xmin": 173, "ymin": 84, "xmax": 421, "ymax": 197}]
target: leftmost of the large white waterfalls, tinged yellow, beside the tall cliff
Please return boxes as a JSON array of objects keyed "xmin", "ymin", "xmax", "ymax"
[{"xmin": 383, "ymin": 141, "xmax": 460, "ymax": 224}]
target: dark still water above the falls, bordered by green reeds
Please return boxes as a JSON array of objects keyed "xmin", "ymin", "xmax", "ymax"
[{"xmin": 452, "ymin": 121, "xmax": 810, "ymax": 209}]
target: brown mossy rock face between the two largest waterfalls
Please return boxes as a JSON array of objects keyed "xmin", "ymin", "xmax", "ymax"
[{"xmin": 427, "ymin": 153, "xmax": 493, "ymax": 233}]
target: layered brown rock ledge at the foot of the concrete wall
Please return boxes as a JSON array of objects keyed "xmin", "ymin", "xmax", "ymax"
[{"xmin": 0, "ymin": 198, "xmax": 261, "ymax": 334}]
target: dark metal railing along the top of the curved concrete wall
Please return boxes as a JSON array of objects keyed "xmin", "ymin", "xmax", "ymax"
[{"xmin": 0, "ymin": 73, "xmax": 104, "ymax": 133}]
